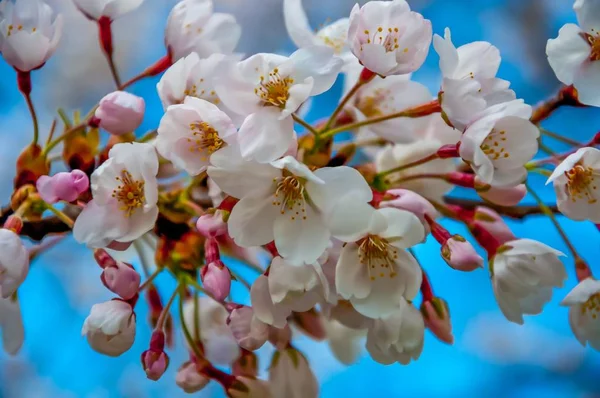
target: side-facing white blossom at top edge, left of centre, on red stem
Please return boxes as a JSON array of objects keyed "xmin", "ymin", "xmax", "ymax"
[{"xmin": 165, "ymin": 0, "xmax": 242, "ymax": 62}]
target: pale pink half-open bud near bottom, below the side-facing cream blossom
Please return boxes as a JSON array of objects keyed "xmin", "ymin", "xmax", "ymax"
[{"xmin": 227, "ymin": 307, "xmax": 269, "ymax": 351}]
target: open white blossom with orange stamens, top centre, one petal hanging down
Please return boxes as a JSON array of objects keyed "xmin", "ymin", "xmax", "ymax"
[{"xmin": 215, "ymin": 46, "xmax": 342, "ymax": 163}]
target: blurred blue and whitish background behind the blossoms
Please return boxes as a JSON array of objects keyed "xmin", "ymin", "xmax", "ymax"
[{"xmin": 0, "ymin": 0, "xmax": 600, "ymax": 398}]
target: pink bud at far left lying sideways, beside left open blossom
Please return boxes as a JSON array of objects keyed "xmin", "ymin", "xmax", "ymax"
[{"xmin": 36, "ymin": 170, "xmax": 90, "ymax": 203}]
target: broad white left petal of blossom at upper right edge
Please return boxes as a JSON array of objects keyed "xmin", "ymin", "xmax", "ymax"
[{"xmin": 546, "ymin": 24, "xmax": 591, "ymax": 84}]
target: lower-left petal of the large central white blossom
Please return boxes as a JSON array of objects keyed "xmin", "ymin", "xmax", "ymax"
[{"xmin": 228, "ymin": 195, "xmax": 280, "ymax": 247}]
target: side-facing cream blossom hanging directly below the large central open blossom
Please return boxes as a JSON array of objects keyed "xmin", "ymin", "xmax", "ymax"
[{"xmin": 250, "ymin": 257, "xmax": 328, "ymax": 329}]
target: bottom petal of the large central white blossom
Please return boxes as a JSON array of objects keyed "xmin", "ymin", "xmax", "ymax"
[{"xmin": 274, "ymin": 204, "xmax": 330, "ymax": 264}]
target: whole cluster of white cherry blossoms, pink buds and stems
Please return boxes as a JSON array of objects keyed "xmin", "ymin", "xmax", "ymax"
[{"xmin": 0, "ymin": 0, "xmax": 600, "ymax": 398}]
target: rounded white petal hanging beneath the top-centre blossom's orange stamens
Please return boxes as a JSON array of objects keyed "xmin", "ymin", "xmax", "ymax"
[{"xmin": 238, "ymin": 107, "xmax": 296, "ymax": 163}]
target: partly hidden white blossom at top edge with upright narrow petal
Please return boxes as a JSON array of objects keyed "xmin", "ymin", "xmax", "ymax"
[{"xmin": 283, "ymin": 0, "xmax": 354, "ymax": 62}]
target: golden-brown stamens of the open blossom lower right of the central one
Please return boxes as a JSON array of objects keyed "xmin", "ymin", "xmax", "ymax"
[{"xmin": 356, "ymin": 235, "xmax": 398, "ymax": 281}]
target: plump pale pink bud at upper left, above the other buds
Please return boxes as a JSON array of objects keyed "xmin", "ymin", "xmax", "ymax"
[{"xmin": 95, "ymin": 91, "xmax": 146, "ymax": 135}]
